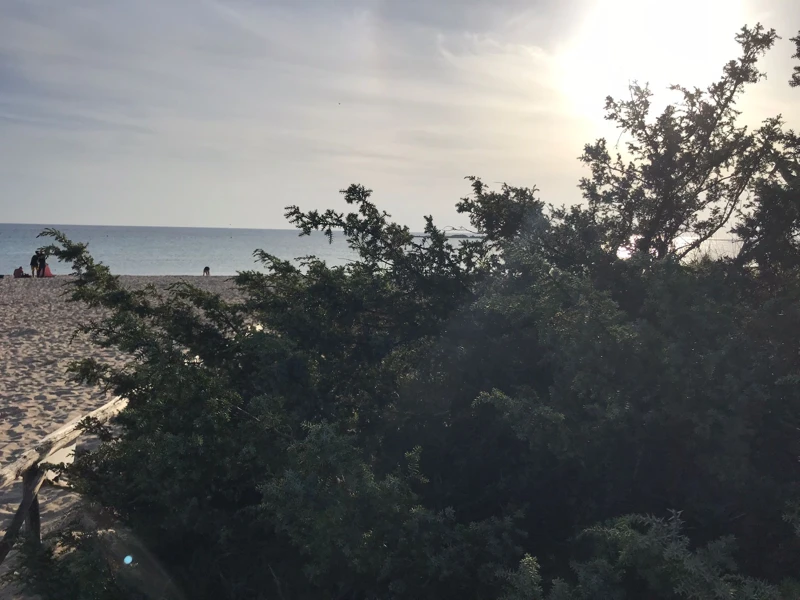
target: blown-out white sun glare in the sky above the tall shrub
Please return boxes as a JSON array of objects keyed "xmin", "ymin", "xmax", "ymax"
[{"xmin": 557, "ymin": 0, "xmax": 748, "ymax": 119}]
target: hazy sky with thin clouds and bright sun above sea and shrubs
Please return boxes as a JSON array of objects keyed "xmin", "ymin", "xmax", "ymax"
[{"xmin": 0, "ymin": 0, "xmax": 800, "ymax": 230}]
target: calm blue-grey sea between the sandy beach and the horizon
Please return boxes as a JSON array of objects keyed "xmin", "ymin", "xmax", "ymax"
[{"xmin": 0, "ymin": 223, "xmax": 355, "ymax": 275}]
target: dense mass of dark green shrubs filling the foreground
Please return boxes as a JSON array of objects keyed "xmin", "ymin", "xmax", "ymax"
[{"xmin": 12, "ymin": 27, "xmax": 800, "ymax": 600}]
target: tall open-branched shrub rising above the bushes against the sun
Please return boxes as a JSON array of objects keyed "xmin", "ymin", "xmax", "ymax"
[{"xmin": 580, "ymin": 25, "xmax": 778, "ymax": 258}]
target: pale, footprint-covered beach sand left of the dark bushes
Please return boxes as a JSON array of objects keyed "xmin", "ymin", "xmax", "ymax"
[{"xmin": 0, "ymin": 275, "xmax": 242, "ymax": 600}]
